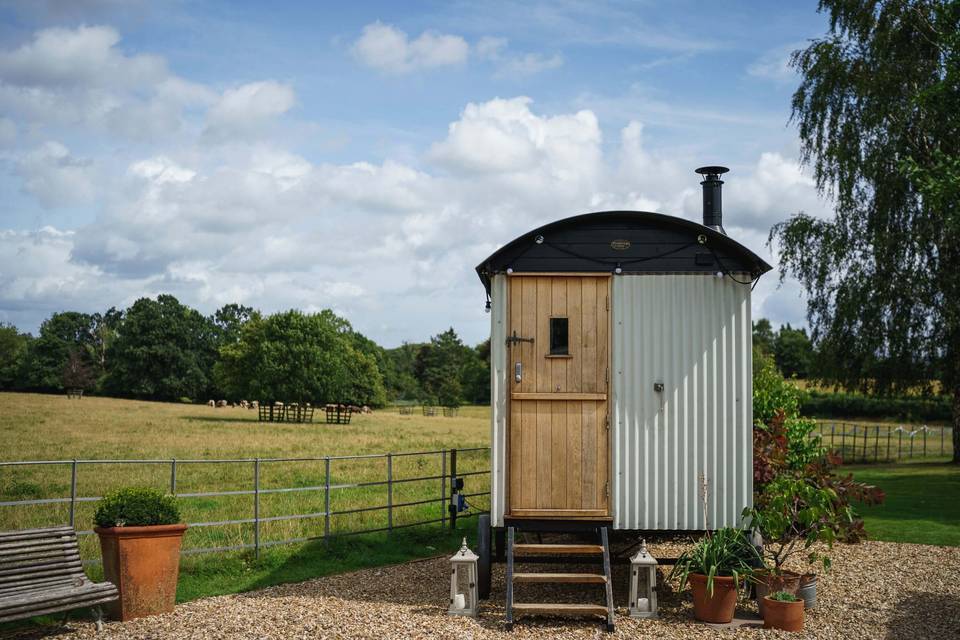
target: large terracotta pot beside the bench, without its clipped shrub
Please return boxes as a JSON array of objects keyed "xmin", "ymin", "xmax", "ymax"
[{"xmin": 94, "ymin": 524, "xmax": 187, "ymax": 620}]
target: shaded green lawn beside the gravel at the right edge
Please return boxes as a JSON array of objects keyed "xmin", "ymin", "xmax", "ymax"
[{"xmin": 846, "ymin": 463, "xmax": 960, "ymax": 546}]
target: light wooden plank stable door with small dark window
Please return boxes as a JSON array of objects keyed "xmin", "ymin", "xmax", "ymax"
[{"xmin": 507, "ymin": 274, "xmax": 610, "ymax": 518}]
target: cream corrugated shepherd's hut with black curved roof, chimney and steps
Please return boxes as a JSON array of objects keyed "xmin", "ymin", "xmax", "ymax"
[{"xmin": 477, "ymin": 166, "xmax": 771, "ymax": 626}]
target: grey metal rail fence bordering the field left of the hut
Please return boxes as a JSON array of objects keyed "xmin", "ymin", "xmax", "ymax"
[{"xmin": 0, "ymin": 447, "xmax": 490, "ymax": 563}]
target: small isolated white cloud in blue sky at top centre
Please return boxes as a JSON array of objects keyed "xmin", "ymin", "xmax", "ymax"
[{"xmin": 353, "ymin": 21, "xmax": 470, "ymax": 73}]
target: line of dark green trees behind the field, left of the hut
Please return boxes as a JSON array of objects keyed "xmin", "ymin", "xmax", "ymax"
[{"xmin": 0, "ymin": 295, "xmax": 490, "ymax": 406}]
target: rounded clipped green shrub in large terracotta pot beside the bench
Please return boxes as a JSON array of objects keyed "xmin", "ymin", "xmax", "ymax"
[{"xmin": 94, "ymin": 488, "xmax": 187, "ymax": 620}]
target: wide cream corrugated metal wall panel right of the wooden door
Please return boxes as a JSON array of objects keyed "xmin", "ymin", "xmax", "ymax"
[{"xmin": 611, "ymin": 274, "xmax": 753, "ymax": 529}]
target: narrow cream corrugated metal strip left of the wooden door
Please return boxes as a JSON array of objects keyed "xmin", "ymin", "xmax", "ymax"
[{"xmin": 490, "ymin": 274, "xmax": 510, "ymax": 527}]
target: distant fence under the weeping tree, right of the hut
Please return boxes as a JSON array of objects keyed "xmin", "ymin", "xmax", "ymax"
[{"xmin": 818, "ymin": 421, "xmax": 953, "ymax": 464}]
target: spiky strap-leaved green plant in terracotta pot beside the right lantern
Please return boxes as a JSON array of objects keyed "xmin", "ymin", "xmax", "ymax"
[{"xmin": 670, "ymin": 529, "xmax": 759, "ymax": 623}]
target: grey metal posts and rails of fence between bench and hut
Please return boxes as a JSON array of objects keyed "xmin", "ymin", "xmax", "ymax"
[{"xmin": 0, "ymin": 447, "xmax": 490, "ymax": 563}]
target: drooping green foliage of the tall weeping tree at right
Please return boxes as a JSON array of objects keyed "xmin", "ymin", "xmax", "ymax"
[{"xmin": 770, "ymin": 0, "xmax": 960, "ymax": 424}]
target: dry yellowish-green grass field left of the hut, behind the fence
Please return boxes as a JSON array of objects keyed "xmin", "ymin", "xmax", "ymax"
[{"xmin": 0, "ymin": 393, "xmax": 489, "ymax": 558}]
